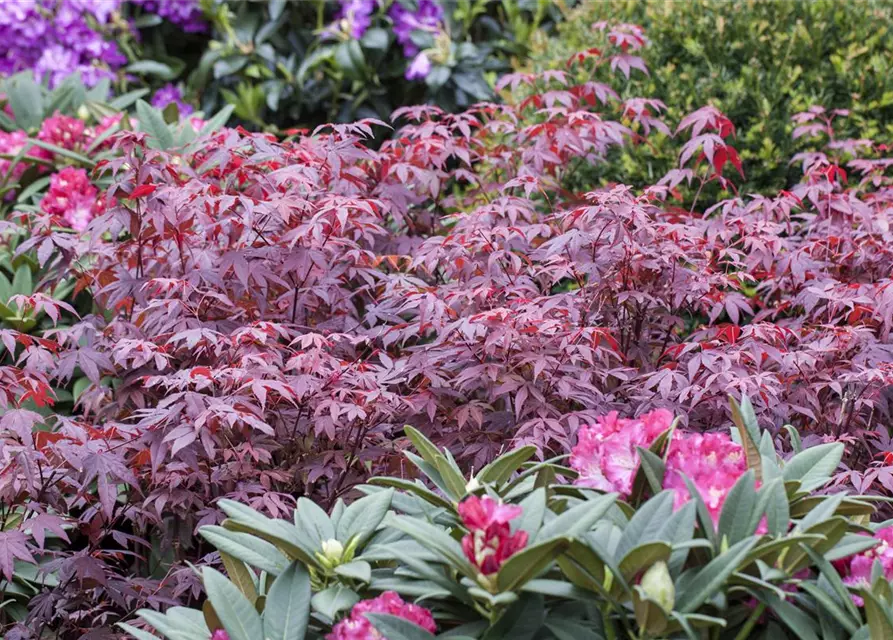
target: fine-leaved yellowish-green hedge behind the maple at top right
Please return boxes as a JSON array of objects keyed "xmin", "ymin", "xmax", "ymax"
[{"xmin": 527, "ymin": 0, "xmax": 893, "ymax": 192}]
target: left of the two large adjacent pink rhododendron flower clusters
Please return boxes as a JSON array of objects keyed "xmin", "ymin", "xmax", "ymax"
[{"xmin": 570, "ymin": 409, "xmax": 673, "ymax": 496}]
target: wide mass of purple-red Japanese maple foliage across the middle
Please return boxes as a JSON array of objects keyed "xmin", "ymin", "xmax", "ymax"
[{"xmin": 0, "ymin": 40, "xmax": 893, "ymax": 637}]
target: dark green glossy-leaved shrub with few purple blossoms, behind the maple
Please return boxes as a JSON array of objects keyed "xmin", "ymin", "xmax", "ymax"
[{"xmin": 180, "ymin": 0, "xmax": 554, "ymax": 128}]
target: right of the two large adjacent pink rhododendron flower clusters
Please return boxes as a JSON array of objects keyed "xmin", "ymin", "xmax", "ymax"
[{"xmin": 664, "ymin": 433, "xmax": 747, "ymax": 522}]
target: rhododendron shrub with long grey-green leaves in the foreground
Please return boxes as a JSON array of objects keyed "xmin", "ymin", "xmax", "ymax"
[{"xmin": 131, "ymin": 408, "xmax": 893, "ymax": 640}]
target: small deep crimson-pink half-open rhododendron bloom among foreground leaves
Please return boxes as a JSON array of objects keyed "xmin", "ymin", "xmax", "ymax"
[{"xmin": 459, "ymin": 496, "xmax": 527, "ymax": 575}]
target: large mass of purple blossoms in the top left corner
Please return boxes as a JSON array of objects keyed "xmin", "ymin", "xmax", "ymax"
[{"xmin": 0, "ymin": 0, "xmax": 127, "ymax": 87}]
